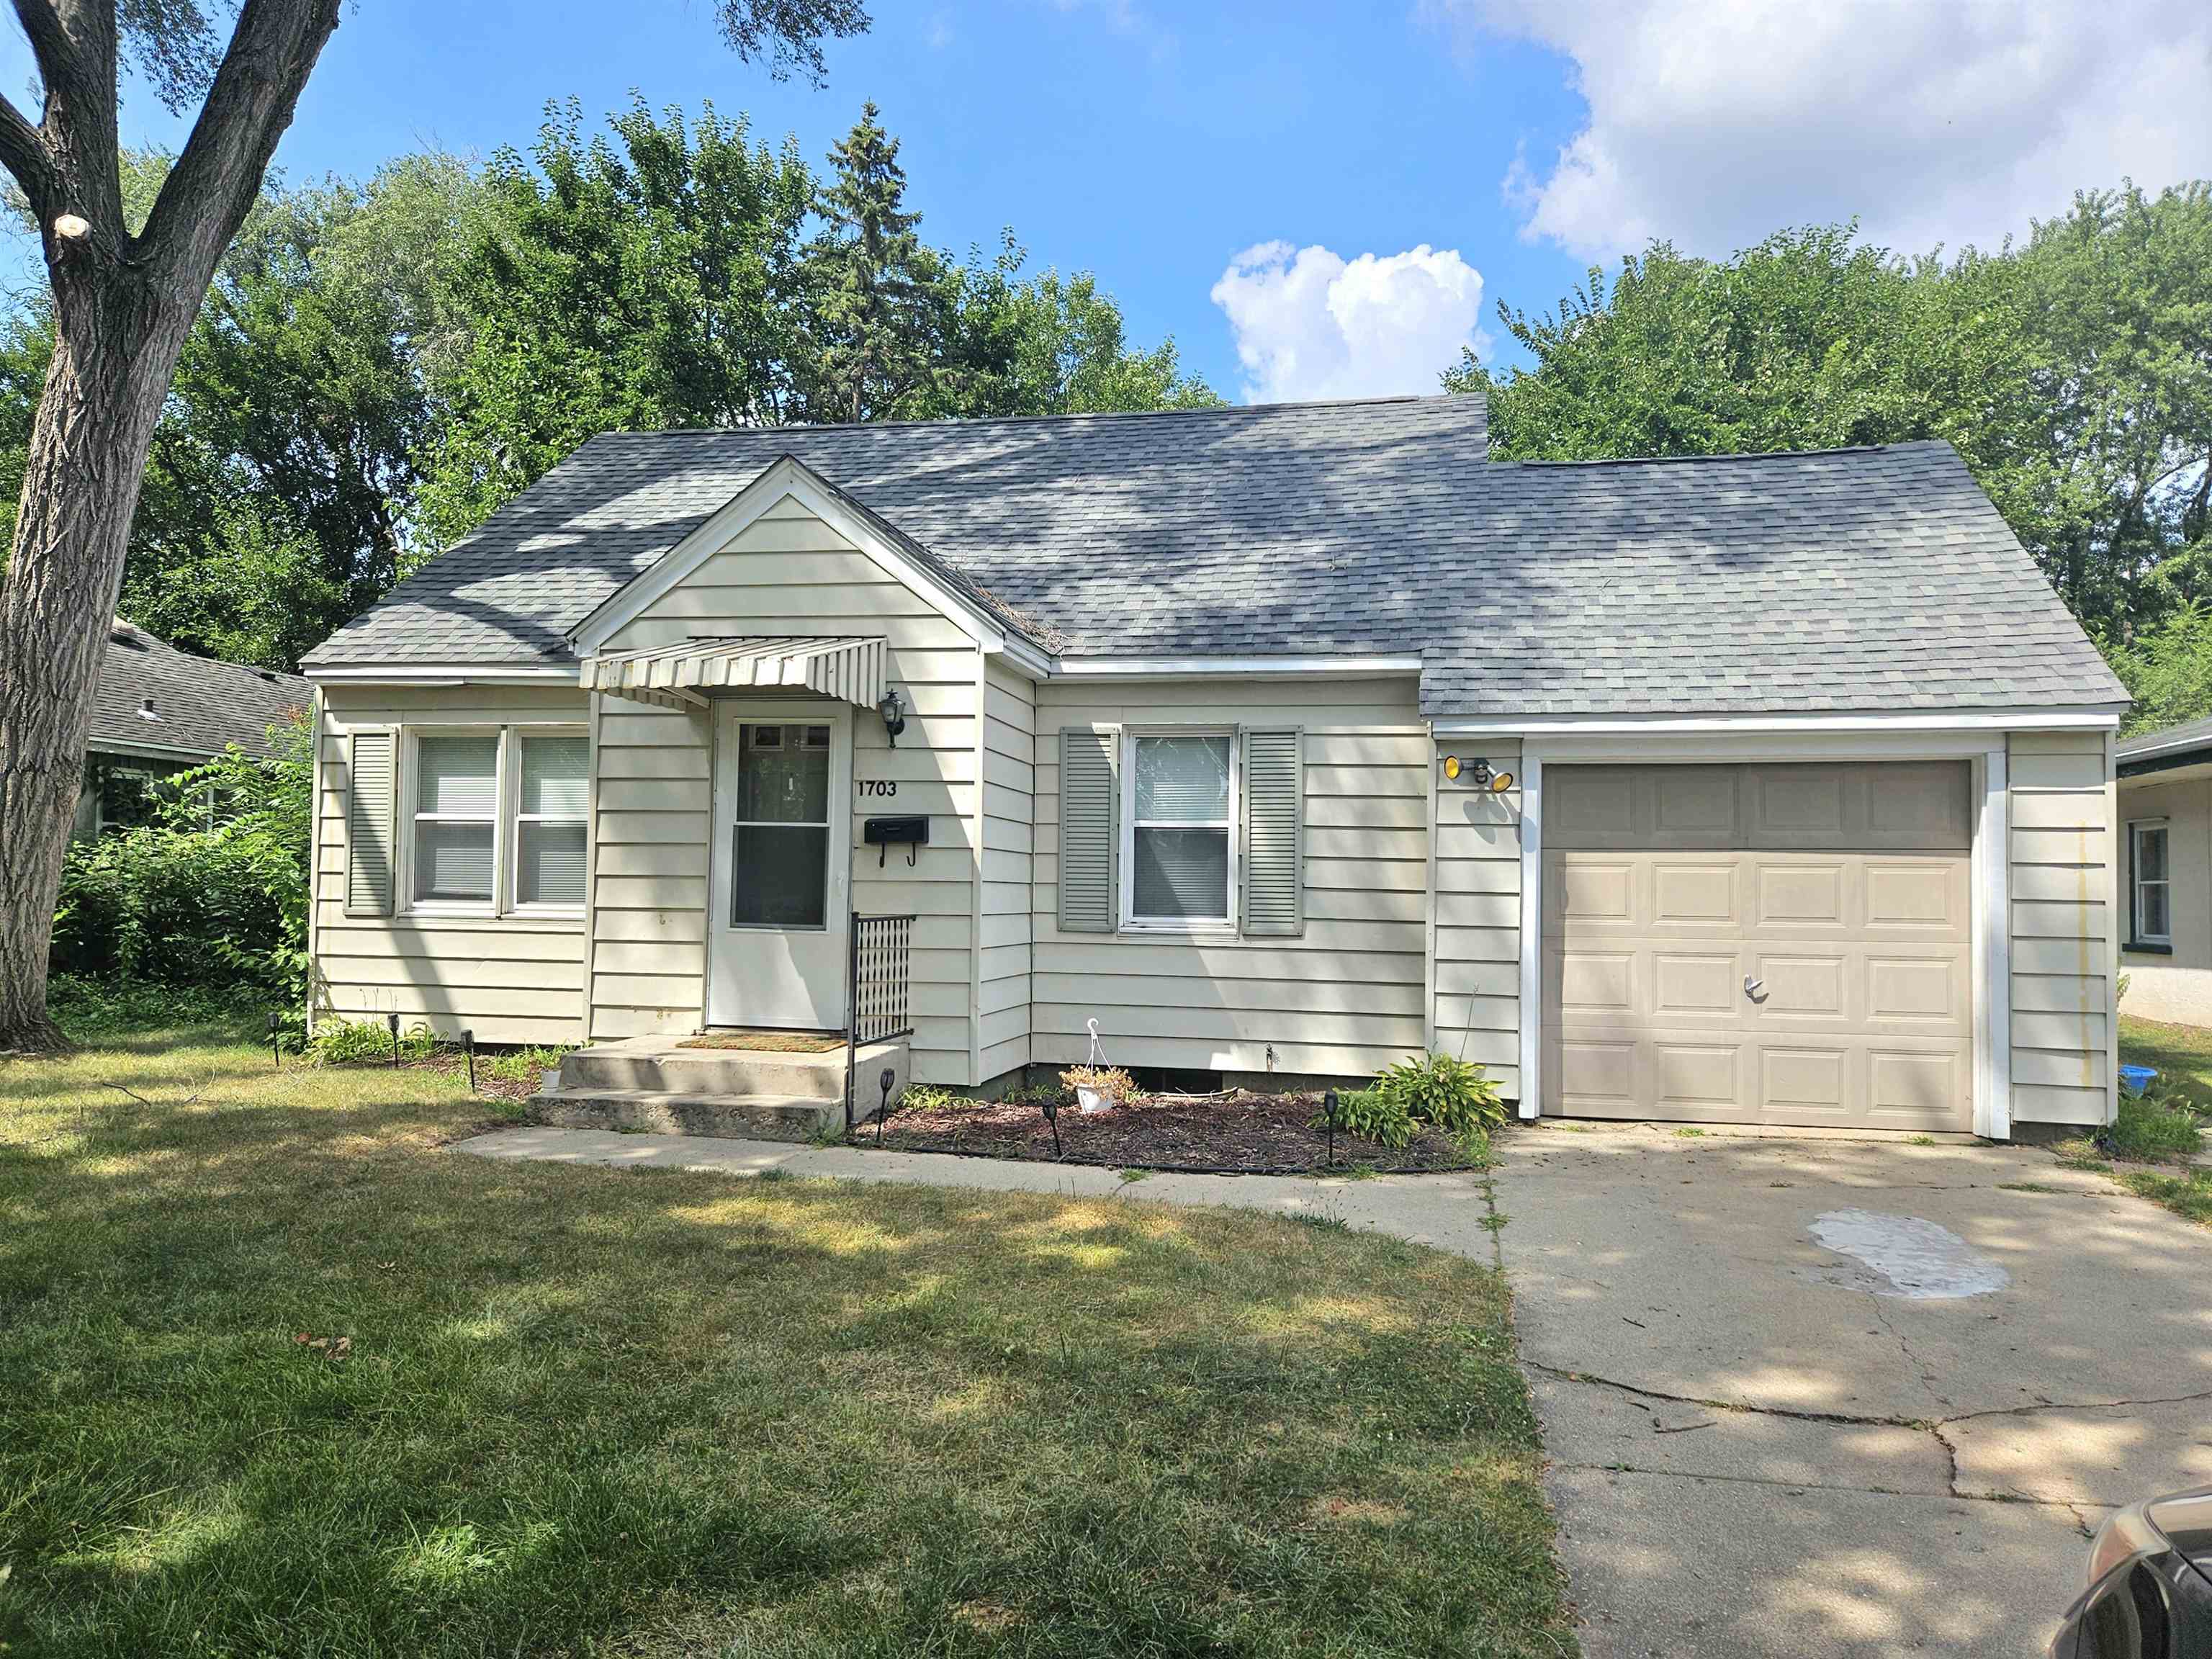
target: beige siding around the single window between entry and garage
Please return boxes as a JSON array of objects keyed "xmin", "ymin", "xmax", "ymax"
[{"xmin": 1028, "ymin": 677, "xmax": 1431, "ymax": 1077}]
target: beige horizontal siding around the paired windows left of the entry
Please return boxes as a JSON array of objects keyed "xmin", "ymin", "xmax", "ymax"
[{"xmin": 314, "ymin": 685, "xmax": 586, "ymax": 1042}]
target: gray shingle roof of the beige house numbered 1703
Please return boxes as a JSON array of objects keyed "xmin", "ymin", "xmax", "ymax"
[{"xmin": 310, "ymin": 396, "xmax": 2126, "ymax": 716}]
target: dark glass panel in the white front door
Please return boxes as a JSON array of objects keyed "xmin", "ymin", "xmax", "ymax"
[{"xmin": 730, "ymin": 726, "xmax": 830, "ymax": 927}]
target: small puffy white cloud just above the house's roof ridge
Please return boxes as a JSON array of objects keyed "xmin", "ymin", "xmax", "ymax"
[{"xmin": 1212, "ymin": 241, "xmax": 1486, "ymax": 403}]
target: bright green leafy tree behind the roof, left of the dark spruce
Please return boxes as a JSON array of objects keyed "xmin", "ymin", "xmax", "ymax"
[{"xmin": 423, "ymin": 102, "xmax": 814, "ymax": 547}]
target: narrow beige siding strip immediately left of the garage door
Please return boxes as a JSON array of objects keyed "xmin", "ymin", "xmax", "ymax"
[{"xmin": 1431, "ymin": 737, "xmax": 1522, "ymax": 1100}]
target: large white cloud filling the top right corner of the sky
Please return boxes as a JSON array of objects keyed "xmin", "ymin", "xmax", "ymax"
[{"xmin": 1426, "ymin": 0, "xmax": 2212, "ymax": 256}]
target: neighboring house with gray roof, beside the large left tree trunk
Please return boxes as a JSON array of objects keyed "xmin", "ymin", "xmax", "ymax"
[{"xmin": 73, "ymin": 617, "xmax": 314, "ymax": 840}]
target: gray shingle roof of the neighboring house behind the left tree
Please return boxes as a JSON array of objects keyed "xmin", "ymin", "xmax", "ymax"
[{"xmin": 86, "ymin": 617, "xmax": 314, "ymax": 755}]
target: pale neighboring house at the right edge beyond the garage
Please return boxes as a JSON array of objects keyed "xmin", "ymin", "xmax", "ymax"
[{"xmin": 2115, "ymin": 719, "xmax": 2212, "ymax": 1026}]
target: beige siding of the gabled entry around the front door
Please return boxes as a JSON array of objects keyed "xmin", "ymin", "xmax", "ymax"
[{"xmin": 590, "ymin": 500, "xmax": 993, "ymax": 1084}]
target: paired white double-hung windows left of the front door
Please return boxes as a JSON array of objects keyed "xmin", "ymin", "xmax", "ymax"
[{"xmin": 400, "ymin": 726, "xmax": 590, "ymax": 916}]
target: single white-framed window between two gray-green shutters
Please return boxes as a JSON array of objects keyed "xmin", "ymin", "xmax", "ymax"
[{"xmin": 1122, "ymin": 732, "xmax": 1236, "ymax": 927}]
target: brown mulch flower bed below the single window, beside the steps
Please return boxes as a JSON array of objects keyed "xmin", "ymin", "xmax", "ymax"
[{"xmin": 854, "ymin": 1090, "xmax": 1469, "ymax": 1174}]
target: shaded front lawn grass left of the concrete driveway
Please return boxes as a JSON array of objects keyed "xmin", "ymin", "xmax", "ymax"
[{"xmin": 0, "ymin": 1031, "xmax": 1575, "ymax": 1657}]
